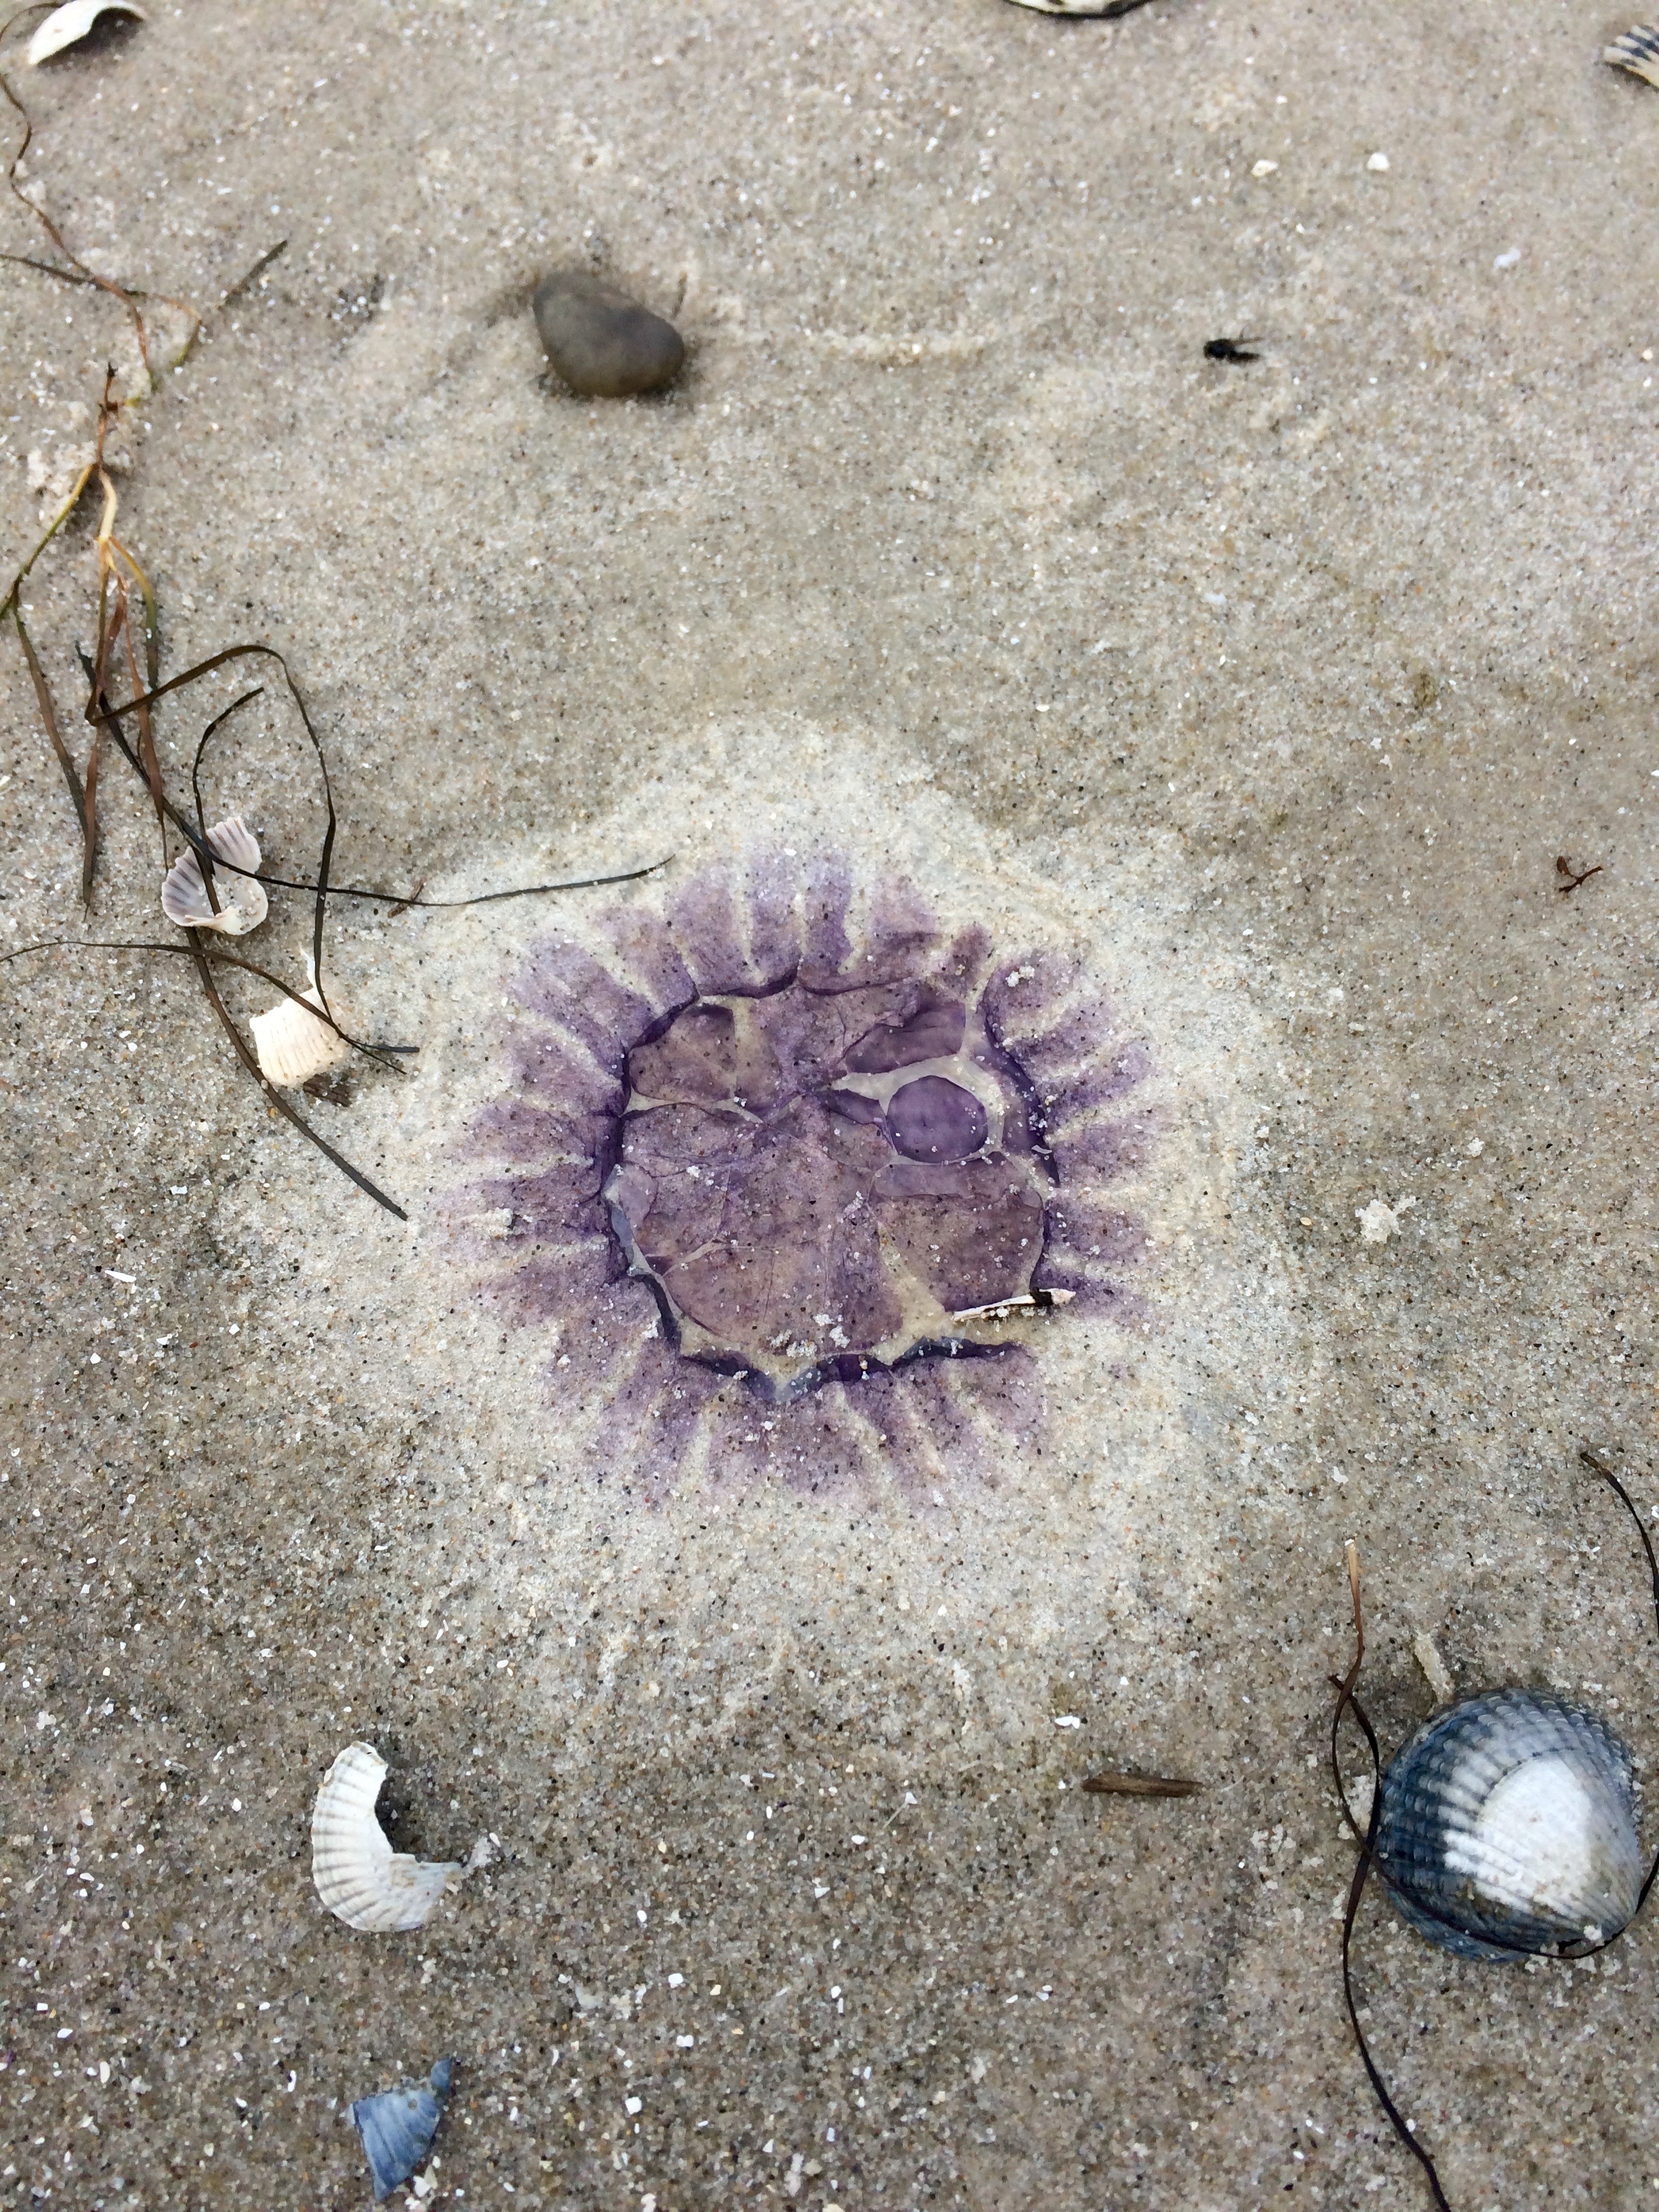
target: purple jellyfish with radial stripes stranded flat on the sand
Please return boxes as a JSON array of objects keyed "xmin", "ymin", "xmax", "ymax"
[{"xmin": 449, "ymin": 852, "xmax": 1155, "ymax": 1495}]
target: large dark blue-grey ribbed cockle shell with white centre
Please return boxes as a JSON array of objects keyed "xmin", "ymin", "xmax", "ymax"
[{"xmin": 1376, "ymin": 1690, "xmax": 1645, "ymax": 1958}]
